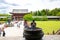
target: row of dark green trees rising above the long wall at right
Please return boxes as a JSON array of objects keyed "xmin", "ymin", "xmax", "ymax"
[{"xmin": 32, "ymin": 8, "xmax": 60, "ymax": 16}]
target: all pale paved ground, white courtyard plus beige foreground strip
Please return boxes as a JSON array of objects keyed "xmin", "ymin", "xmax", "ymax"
[{"xmin": 0, "ymin": 21, "xmax": 60, "ymax": 40}]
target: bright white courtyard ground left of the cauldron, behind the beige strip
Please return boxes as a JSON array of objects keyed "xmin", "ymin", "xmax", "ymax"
[{"xmin": 5, "ymin": 21, "xmax": 24, "ymax": 37}]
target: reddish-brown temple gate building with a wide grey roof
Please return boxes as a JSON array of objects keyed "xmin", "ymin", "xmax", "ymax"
[{"xmin": 10, "ymin": 9, "xmax": 29, "ymax": 20}]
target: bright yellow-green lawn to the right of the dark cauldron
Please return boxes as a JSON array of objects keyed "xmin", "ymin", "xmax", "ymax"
[{"xmin": 36, "ymin": 21, "xmax": 60, "ymax": 34}]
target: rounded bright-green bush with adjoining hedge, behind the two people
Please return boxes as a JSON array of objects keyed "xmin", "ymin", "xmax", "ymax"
[{"xmin": 23, "ymin": 14, "xmax": 48, "ymax": 21}]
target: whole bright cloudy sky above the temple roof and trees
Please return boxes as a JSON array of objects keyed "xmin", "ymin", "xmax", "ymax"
[{"xmin": 0, "ymin": 0, "xmax": 60, "ymax": 13}]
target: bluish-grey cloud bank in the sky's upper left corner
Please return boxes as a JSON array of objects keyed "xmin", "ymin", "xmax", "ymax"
[{"xmin": 0, "ymin": 0, "xmax": 18, "ymax": 13}]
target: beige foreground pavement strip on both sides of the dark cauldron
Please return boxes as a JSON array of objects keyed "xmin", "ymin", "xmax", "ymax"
[{"xmin": 0, "ymin": 35, "xmax": 60, "ymax": 40}]
